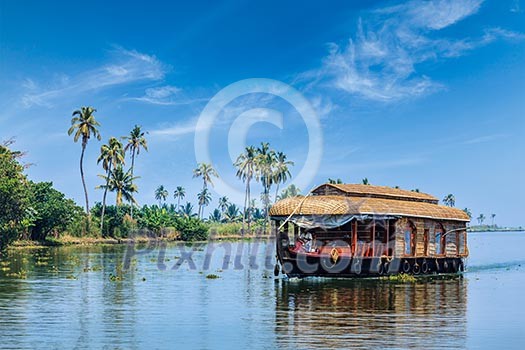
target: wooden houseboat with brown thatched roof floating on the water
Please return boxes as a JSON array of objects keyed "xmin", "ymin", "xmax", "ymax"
[{"xmin": 270, "ymin": 184, "xmax": 470, "ymax": 277}]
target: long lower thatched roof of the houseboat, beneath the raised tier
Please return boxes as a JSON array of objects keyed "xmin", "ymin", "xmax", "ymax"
[{"xmin": 270, "ymin": 195, "xmax": 470, "ymax": 221}]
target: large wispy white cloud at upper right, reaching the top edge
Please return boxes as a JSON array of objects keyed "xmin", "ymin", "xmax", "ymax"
[{"xmin": 302, "ymin": 0, "xmax": 523, "ymax": 102}]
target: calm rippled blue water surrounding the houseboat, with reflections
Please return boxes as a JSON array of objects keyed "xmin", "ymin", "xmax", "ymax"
[{"xmin": 0, "ymin": 233, "xmax": 525, "ymax": 349}]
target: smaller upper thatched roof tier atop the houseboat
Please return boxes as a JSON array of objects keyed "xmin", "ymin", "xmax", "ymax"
[{"xmin": 312, "ymin": 184, "xmax": 438, "ymax": 204}]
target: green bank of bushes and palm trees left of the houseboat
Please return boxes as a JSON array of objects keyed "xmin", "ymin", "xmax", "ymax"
[{"xmin": 0, "ymin": 106, "xmax": 300, "ymax": 249}]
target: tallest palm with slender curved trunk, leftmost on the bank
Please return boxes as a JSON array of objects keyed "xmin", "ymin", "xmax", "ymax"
[{"xmin": 67, "ymin": 107, "xmax": 100, "ymax": 216}]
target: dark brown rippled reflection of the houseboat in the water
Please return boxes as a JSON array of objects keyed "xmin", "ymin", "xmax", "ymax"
[{"xmin": 276, "ymin": 277, "xmax": 467, "ymax": 349}]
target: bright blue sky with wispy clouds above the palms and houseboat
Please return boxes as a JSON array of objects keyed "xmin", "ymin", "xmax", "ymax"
[{"xmin": 0, "ymin": 0, "xmax": 525, "ymax": 225}]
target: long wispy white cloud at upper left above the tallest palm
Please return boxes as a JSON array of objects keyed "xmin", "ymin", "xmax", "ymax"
[{"xmin": 21, "ymin": 47, "xmax": 169, "ymax": 107}]
